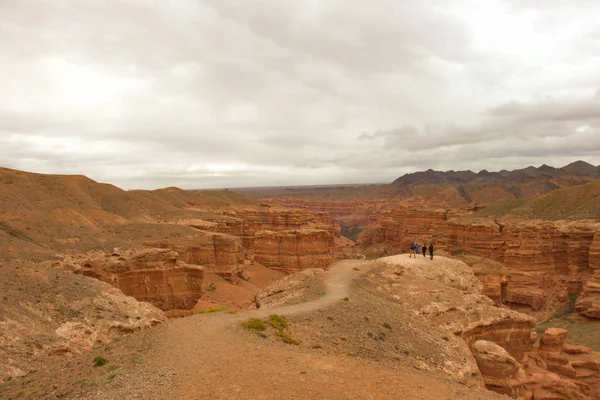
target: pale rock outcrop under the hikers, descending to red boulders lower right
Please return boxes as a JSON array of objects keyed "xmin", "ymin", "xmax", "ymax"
[{"xmin": 377, "ymin": 255, "xmax": 600, "ymax": 400}]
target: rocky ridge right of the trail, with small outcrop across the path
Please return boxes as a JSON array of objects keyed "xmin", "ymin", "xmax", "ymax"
[{"xmin": 258, "ymin": 255, "xmax": 600, "ymax": 400}]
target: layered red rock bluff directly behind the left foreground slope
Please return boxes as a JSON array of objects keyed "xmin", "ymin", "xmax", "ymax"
[{"xmin": 67, "ymin": 249, "xmax": 204, "ymax": 310}]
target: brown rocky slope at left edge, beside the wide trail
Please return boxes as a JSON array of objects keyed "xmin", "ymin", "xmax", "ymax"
[{"xmin": 0, "ymin": 263, "xmax": 166, "ymax": 382}]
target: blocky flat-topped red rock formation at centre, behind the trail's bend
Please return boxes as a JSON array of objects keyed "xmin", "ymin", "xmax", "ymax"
[{"xmin": 254, "ymin": 229, "xmax": 332, "ymax": 271}]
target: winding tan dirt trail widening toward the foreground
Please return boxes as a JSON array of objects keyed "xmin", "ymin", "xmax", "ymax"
[{"xmin": 94, "ymin": 260, "xmax": 504, "ymax": 400}]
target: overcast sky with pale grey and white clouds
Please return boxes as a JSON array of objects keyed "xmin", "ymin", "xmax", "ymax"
[{"xmin": 0, "ymin": 0, "xmax": 600, "ymax": 189}]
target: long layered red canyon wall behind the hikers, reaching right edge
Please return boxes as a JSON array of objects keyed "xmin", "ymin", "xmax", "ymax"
[{"xmin": 358, "ymin": 208, "xmax": 600, "ymax": 316}]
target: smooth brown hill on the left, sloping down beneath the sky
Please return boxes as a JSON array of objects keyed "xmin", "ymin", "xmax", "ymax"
[{"xmin": 0, "ymin": 168, "xmax": 257, "ymax": 259}]
